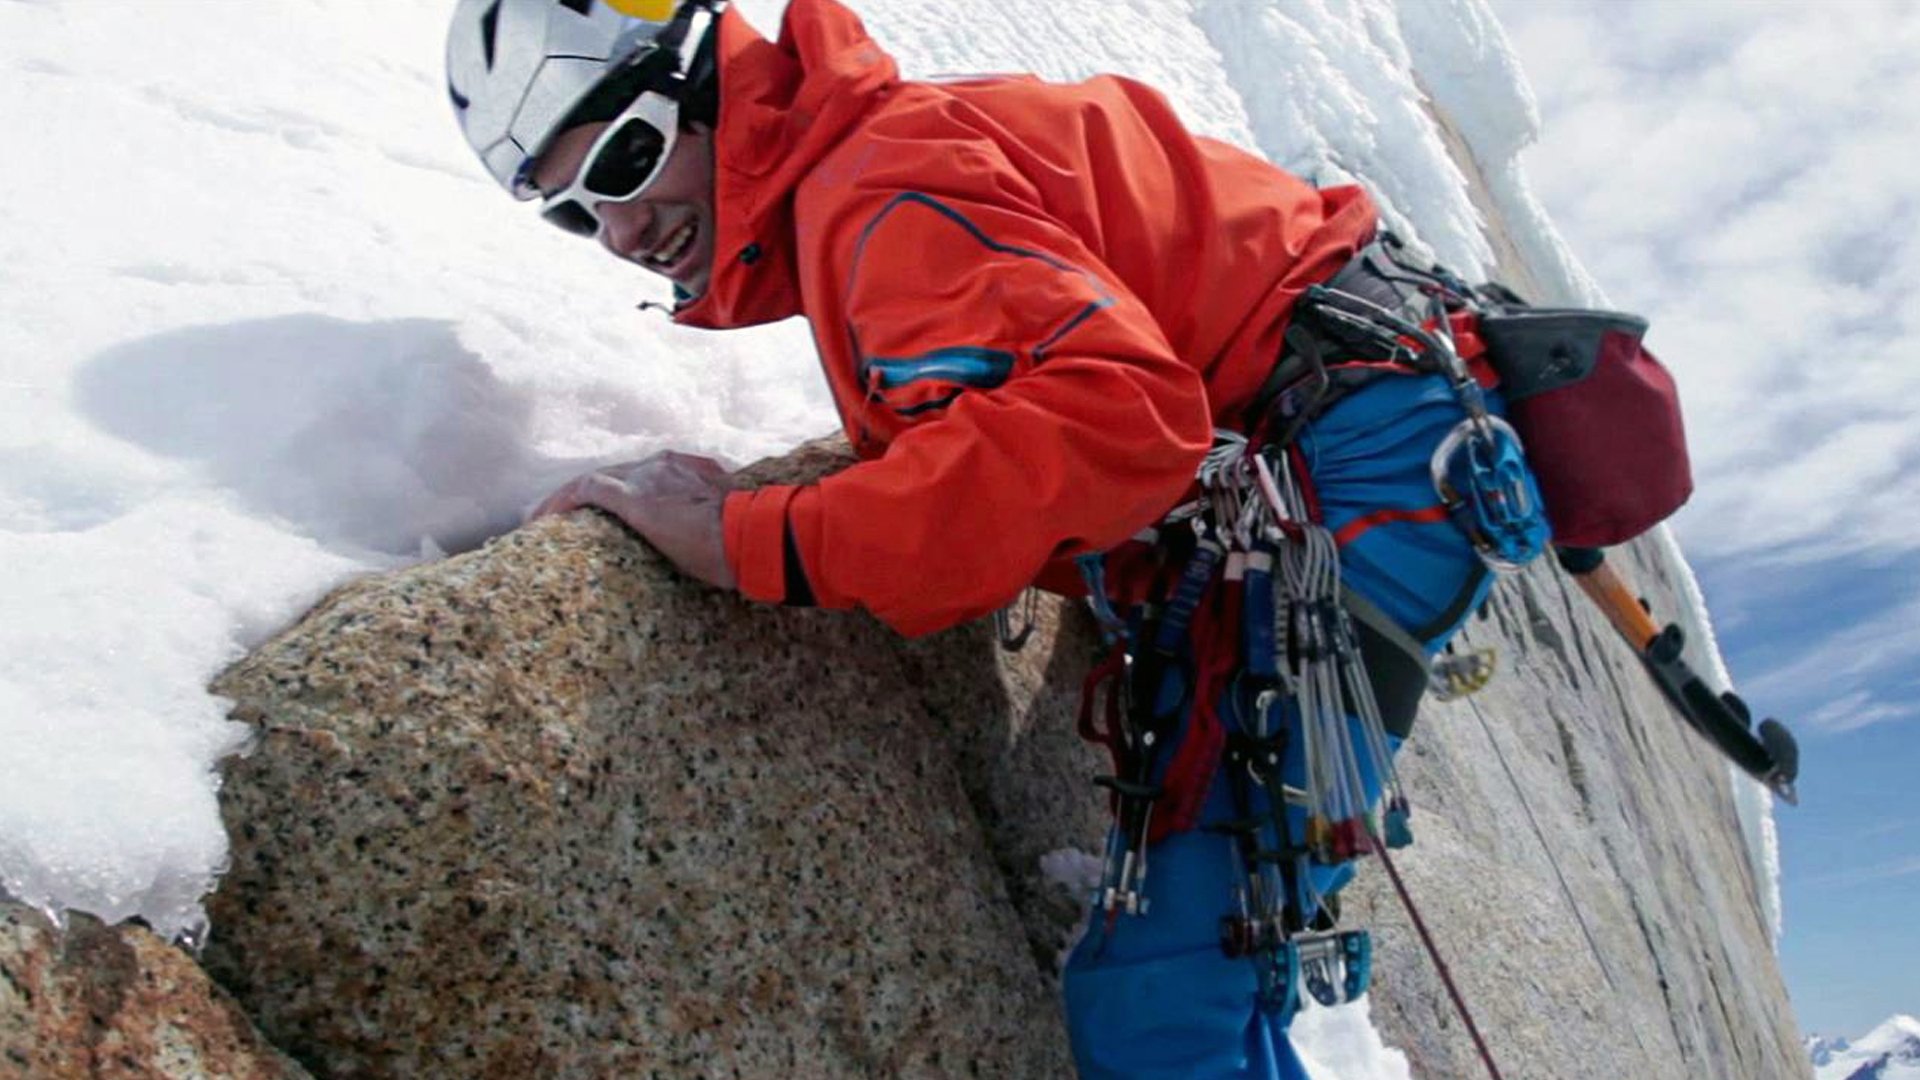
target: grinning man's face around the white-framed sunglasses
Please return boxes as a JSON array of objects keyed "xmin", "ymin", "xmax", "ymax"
[{"xmin": 532, "ymin": 123, "xmax": 714, "ymax": 296}]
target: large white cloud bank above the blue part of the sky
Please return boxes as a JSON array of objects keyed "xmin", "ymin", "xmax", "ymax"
[{"xmin": 1498, "ymin": 2, "xmax": 1920, "ymax": 561}]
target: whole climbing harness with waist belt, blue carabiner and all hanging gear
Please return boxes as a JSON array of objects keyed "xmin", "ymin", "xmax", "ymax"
[{"xmin": 1079, "ymin": 228, "xmax": 1548, "ymax": 1037}]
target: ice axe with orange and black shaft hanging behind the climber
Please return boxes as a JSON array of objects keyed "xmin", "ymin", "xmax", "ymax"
[{"xmin": 1553, "ymin": 548, "xmax": 1799, "ymax": 805}]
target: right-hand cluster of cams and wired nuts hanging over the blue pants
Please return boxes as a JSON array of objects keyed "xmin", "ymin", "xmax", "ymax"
[{"xmin": 1200, "ymin": 432, "xmax": 1411, "ymax": 1017}]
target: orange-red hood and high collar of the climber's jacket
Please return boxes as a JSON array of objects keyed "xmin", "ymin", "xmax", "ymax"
[{"xmin": 674, "ymin": 0, "xmax": 900, "ymax": 329}]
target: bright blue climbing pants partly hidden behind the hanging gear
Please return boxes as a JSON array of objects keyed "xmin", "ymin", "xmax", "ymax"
[{"xmin": 1064, "ymin": 377, "xmax": 1498, "ymax": 1080}]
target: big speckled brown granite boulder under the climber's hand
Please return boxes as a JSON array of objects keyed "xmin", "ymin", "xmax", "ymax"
[{"xmin": 205, "ymin": 438, "xmax": 1100, "ymax": 1078}]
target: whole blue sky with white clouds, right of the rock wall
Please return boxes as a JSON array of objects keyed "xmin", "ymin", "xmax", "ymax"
[{"xmin": 1496, "ymin": 0, "xmax": 1920, "ymax": 1036}]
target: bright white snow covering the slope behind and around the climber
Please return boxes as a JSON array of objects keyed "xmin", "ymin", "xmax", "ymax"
[{"xmin": 0, "ymin": 0, "xmax": 1776, "ymax": 1060}]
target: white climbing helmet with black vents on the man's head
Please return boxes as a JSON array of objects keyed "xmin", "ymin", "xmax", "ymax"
[{"xmin": 447, "ymin": 0, "xmax": 718, "ymax": 200}]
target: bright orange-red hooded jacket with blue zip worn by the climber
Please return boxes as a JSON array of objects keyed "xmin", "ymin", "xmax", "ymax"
[{"xmin": 691, "ymin": 0, "xmax": 1375, "ymax": 634}]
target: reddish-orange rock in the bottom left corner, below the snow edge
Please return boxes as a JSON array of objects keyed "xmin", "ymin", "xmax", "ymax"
[{"xmin": 0, "ymin": 903, "xmax": 307, "ymax": 1080}]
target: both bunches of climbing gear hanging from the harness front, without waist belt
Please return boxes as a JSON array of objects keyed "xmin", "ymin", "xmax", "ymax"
[{"xmin": 1081, "ymin": 432, "xmax": 1411, "ymax": 1017}]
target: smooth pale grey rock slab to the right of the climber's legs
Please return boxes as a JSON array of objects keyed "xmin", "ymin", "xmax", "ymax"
[{"xmin": 1346, "ymin": 542, "xmax": 1809, "ymax": 1080}]
